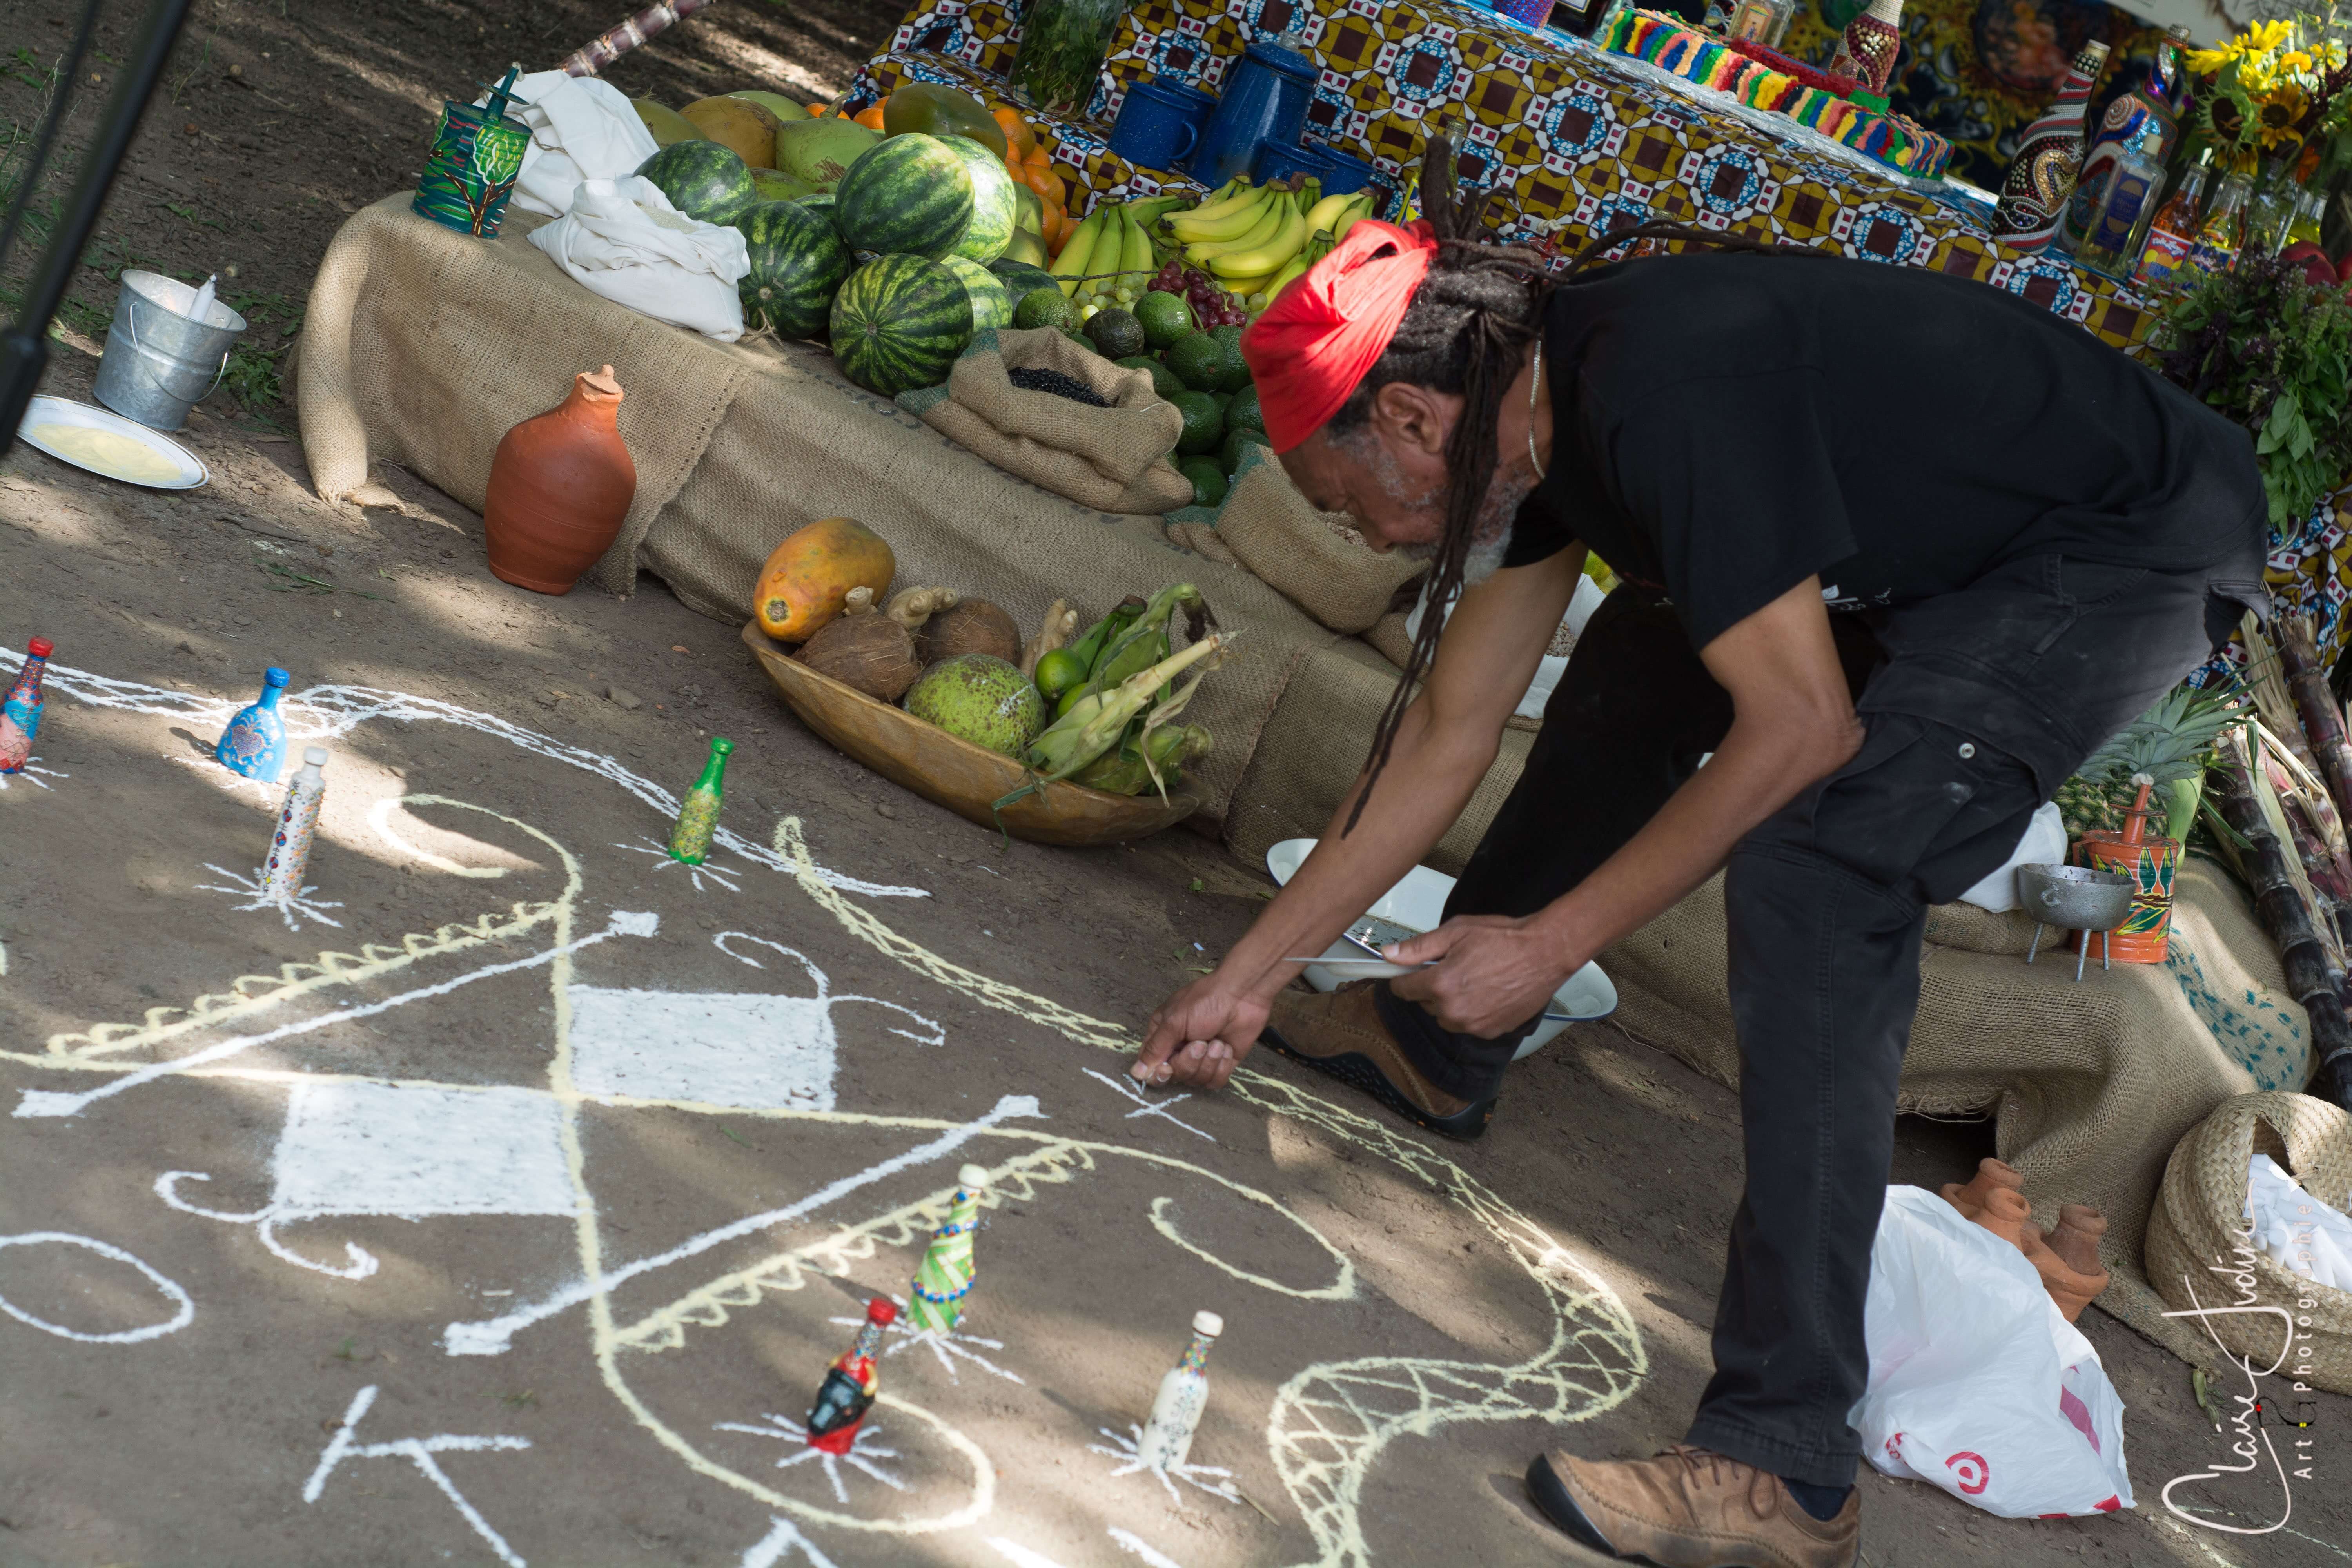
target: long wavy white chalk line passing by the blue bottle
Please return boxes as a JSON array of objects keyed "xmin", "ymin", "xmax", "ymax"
[{"xmin": 0, "ymin": 649, "xmax": 931, "ymax": 898}]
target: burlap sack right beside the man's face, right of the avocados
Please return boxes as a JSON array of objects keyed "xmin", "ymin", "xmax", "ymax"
[{"xmin": 1216, "ymin": 444, "xmax": 1428, "ymax": 632}]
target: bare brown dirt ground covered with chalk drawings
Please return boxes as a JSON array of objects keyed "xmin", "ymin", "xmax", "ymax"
[{"xmin": 0, "ymin": 0, "xmax": 2352, "ymax": 1568}]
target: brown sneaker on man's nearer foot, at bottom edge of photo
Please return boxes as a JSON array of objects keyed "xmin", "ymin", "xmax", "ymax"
[{"xmin": 1526, "ymin": 1443, "xmax": 1863, "ymax": 1568}]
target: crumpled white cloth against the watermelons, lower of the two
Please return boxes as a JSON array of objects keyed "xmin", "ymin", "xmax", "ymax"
[{"xmin": 532, "ymin": 176, "xmax": 750, "ymax": 343}]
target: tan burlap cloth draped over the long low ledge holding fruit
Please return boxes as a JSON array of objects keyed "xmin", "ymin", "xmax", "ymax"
[{"xmin": 296, "ymin": 195, "xmax": 2307, "ymax": 1354}]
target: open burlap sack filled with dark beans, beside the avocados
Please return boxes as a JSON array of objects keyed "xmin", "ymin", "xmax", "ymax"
[{"xmin": 898, "ymin": 327, "xmax": 1192, "ymax": 512}]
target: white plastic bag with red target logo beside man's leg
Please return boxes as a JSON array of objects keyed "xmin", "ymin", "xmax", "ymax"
[{"xmin": 1849, "ymin": 1187, "xmax": 2131, "ymax": 1519}]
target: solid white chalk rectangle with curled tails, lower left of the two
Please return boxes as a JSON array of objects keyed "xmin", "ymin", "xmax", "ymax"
[{"xmin": 155, "ymin": 1082, "xmax": 576, "ymax": 1279}]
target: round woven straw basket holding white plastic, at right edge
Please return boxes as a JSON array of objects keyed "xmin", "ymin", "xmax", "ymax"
[{"xmin": 2147, "ymin": 1093, "xmax": 2352, "ymax": 1394}]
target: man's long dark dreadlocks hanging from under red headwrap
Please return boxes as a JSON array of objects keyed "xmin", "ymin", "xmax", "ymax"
[{"xmin": 1324, "ymin": 134, "xmax": 1820, "ymax": 837}]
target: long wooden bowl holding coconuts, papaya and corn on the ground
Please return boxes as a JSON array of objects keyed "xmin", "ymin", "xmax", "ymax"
[{"xmin": 743, "ymin": 621, "xmax": 1200, "ymax": 844}]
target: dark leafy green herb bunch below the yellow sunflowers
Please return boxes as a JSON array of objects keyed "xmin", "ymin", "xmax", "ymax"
[{"xmin": 2157, "ymin": 249, "xmax": 2352, "ymax": 529}]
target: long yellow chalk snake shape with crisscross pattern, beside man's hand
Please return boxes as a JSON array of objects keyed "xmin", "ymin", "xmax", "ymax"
[{"xmin": 776, "ymin": 818, "xmax": 1649, "ymax": 1568}]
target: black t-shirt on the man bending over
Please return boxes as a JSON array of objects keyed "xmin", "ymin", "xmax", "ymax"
[{"xmin": 1505, "ymin": 252, "xmax": 2267, "ymax": 649}]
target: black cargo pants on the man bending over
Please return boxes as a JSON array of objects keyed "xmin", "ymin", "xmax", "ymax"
[{"xmin": 1381, "ymin": 550, "xmax": 2263, "ymax": 1486}]
